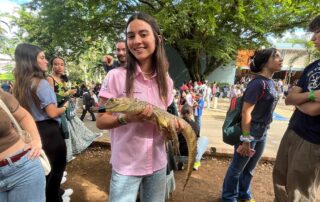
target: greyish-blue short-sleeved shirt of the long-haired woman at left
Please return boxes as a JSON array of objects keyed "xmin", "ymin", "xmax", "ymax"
[{"xmin": 30, "ymin": 79, "xmax": 60, "ymax": 122}]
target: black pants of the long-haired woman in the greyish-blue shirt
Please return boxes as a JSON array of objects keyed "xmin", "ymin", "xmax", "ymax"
[{"xmin": 37, "ymin": 119, "xmax": 67, "ymax": 202}]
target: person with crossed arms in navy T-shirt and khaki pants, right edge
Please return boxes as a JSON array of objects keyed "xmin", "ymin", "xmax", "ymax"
[{"xmin": 273, "ymin": 15, "xmax": 320, "ymax": 202}]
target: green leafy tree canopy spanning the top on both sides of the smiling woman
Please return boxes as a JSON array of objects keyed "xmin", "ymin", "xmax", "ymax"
[{"xmin": 9, "ymin": 0, "xmax": 320, "ymax": 80}]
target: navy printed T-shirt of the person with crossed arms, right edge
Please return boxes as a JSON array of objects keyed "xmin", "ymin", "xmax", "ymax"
[{"xmin": 289, "ymin": 60, "xmax": 320, "ymax": 144}]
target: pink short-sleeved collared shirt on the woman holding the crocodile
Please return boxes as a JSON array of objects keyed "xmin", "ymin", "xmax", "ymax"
[{"xmin": 99, "ymin": 66, "xmax": 173, "ymax": 176}]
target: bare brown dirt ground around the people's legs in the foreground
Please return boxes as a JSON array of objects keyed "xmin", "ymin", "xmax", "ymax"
[{"xmin": 63, "ymin": 145, "xmax": 274, "ymax": 202}]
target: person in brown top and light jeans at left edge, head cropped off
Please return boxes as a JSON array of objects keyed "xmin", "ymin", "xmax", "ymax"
[{"xmin": 0, "ymin": 89, "xmax": 46, "ymax": 202}]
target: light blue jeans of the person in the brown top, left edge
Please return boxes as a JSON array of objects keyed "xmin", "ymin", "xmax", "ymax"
[{"xmin": 0, "ymin": 151, "xmax": 46, "ymax": 202}]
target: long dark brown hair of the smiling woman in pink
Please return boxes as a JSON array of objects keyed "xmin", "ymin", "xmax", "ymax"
[{"xmin": 126, "ymin": 12, "xmax": 169, "ymax": 104}]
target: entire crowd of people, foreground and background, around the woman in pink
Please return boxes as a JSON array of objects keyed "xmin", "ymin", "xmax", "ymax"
[{"xmin": 0, "ymin": 12, "xmax": 320, "ymax": 202}]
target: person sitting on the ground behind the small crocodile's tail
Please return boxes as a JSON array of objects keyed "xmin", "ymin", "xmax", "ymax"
[{"xmin": 177, "ymin": 104, "xmax": 208, "ymax": 170}]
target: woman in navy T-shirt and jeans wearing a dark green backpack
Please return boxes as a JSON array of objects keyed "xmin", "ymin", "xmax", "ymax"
[{"xmin": 222, "ymin": 48, "xmax": 283, "ymax": 202}]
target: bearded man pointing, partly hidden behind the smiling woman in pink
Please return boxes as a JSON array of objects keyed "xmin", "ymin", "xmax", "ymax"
[{"xmin": 102, "ymin": 40, "xmax": 127, "ymax": 72}]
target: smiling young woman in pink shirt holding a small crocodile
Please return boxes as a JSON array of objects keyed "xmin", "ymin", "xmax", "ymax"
[{"xmin": 97, "ymin": 13, "xmax": 183, "ymax": 202}]
